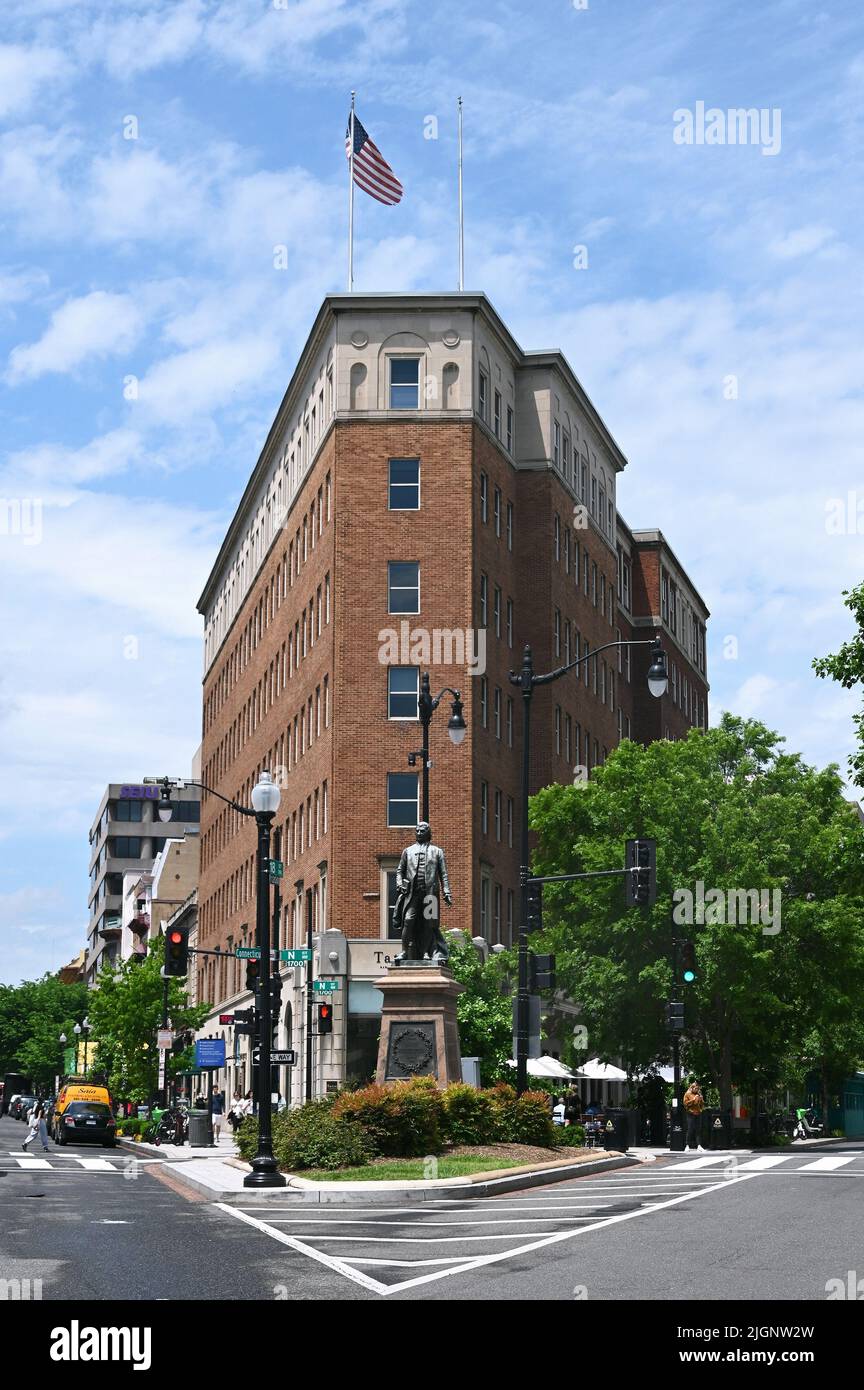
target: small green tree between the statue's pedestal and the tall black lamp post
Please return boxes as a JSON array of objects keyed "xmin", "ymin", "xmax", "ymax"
[{"xmin": 449, "ymin": 940, "xmax": 515, "ymax": 1086}]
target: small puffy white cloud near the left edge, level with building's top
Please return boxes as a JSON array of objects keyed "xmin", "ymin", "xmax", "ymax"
[{"xmin": 7, "ymin": 289, "xmax": 144, "ymax": 384}]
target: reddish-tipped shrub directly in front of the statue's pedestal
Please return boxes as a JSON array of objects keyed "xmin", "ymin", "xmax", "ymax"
[{"xmin": 333, "ymin": 1076, "xmax": 445, "ymax": 1158}]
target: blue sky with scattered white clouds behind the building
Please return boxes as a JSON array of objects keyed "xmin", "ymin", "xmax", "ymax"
[{"xmin": 0, "ymin": 0, "xmax": 864, "ymax": 983}]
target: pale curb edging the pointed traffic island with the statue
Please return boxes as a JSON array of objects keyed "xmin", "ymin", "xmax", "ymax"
[{"xmin": 161, "ymin": 1154, "xmax": 640, "ymax": 1207}]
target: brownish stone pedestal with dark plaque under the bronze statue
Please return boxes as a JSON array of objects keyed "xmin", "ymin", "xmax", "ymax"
[{"xmin": 375, "ymin": 960, "xmax": 464, "ymax": 1087}]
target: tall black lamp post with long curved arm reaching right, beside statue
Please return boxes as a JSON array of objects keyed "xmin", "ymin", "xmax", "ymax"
[{"xmin": 510, "ymin": 637, "xmax": 668, "ymax": 1095}]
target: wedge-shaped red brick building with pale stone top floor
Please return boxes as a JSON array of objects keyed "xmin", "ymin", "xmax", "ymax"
[{"xmin": 199, "ymin": 293, "xmax": 708, "ymax": 1098}]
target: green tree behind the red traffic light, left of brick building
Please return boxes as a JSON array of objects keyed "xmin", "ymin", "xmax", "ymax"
[{"xmin": 89, "ymin": 937, "xmax": 208, "ymax": 1101}]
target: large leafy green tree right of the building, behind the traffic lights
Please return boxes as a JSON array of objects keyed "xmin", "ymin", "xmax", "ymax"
[{"xmin": 531, "ymin": 714, "xmax": 864, "ymax": 1108}]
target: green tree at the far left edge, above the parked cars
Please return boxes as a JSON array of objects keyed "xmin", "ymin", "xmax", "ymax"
[{"xmin": 0, "ymin": 974, "xmax": 89, "ymax": 1090}]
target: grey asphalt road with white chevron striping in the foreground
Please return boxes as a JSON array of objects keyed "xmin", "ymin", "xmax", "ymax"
[{"xmin": 0, "ymin": 1118, "xmax": 864, "ymax": 1302}]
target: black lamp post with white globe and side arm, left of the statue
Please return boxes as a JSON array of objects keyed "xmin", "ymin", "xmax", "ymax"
[{"xmin": 158, "ymin": 771, "xmax": 285, "ymax": 1187}]
